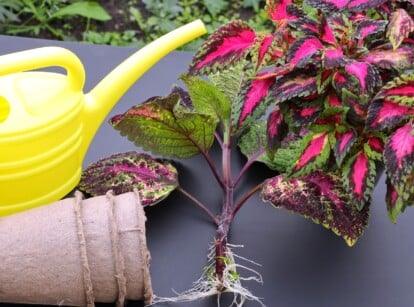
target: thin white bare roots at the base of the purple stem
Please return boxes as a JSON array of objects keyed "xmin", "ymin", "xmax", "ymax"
[{"xmin": 151, "ymin": 244, "xmax": 265, "ymax": 307}]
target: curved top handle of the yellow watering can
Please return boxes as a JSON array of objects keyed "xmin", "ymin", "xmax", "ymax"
[{"xmin": 0, "ymin": 47, "xmax": 85, "ymax": 91}]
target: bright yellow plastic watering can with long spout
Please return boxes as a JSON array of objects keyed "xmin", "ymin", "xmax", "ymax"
[{"xmin": 0, "ymin": 20, "xmax": 206, "ymax": 216}]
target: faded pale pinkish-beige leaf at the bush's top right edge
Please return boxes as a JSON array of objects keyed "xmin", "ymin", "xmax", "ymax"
[{"xmin": 386, "ymin": 8, "xmax": 414, "ymax": 50}]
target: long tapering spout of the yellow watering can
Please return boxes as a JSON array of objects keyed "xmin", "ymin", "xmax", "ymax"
[{"xmin": 82, "ymin": 20, "xmax": 206, "ymax": 154}]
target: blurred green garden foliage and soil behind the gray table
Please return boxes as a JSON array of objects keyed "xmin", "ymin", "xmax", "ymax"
[{"xmin": 0, "ymin": 0, "xmax": 268, "ymax": 51}]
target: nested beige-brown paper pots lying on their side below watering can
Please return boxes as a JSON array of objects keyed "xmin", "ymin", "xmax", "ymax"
[{"xmin": 0, "ymin": 192, "xmax": 153, "ymax": 306}]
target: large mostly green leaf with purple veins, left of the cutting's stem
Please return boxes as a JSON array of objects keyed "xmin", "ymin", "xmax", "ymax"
[{"xmin": 110, "ymin": 94, "xmax": 218, "ymax": 158}]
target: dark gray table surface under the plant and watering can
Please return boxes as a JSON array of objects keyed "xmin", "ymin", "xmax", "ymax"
[{"xmin": 0, "ymin": 36, "xmax": 414, "ymax": 307}]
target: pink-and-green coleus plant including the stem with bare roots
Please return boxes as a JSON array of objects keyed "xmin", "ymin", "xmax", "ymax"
[{"xmin": 81, "ymin": 0, "xmax": 414, "ymax": 306}]
